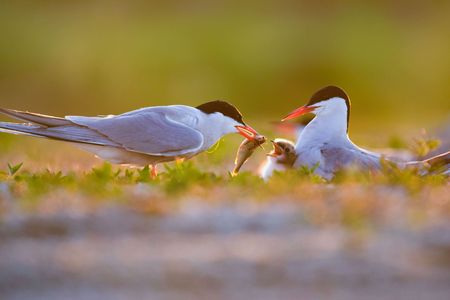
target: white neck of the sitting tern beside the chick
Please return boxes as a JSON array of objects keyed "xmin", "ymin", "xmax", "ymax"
[{"xmin": 296, "ymin": 106, "xmax": 349, "ymax": 148}]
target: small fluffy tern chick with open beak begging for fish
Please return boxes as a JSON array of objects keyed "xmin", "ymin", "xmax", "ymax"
[{"xmin": 259, "ymin": 138, "xmax": 297, "ymax": 181}]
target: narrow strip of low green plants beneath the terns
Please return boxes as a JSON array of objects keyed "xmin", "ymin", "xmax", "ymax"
[{"xmin": 0, "ymin": 147, "xmax": 448, "ymax": 223}]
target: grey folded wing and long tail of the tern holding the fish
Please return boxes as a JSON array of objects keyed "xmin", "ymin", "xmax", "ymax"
[{"xmin": 0, "ymin": 107, "xmax": 203, "ymax": 156}]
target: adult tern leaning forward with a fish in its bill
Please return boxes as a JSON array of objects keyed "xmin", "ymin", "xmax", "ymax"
[{"xmin": 0, "ymin": 101, "xmax": 257, "ymax": 176}]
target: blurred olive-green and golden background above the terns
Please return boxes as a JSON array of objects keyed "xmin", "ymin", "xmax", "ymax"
[{"xmin": 0, "ymin": 0, "xmax": 450, "ymax": 135}]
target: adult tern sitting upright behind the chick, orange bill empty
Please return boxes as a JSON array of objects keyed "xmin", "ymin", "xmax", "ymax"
[{"xmin": 282, "ymin": 86, "xmax": 450, "ymax": 179}]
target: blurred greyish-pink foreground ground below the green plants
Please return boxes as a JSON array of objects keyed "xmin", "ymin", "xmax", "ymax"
[{"xmin": 0, "ymin": 189, "xmax": 450, "ymax": 300}]
